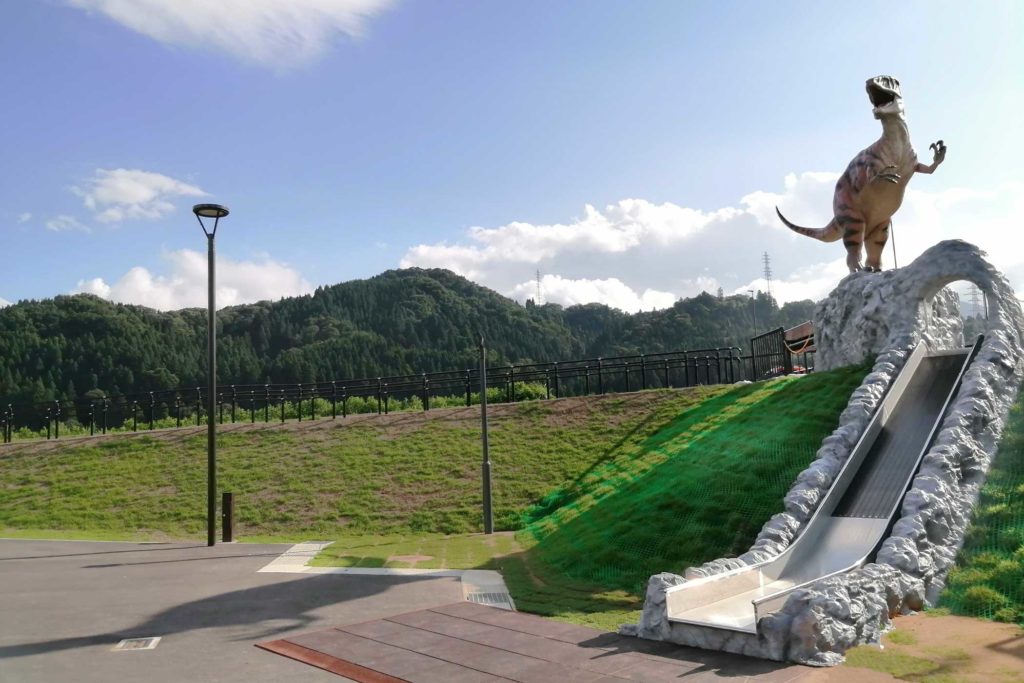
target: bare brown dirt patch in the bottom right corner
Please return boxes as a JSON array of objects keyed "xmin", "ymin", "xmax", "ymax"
[{"xmin": 801, "ymin": 614, "xmax": 1024, "ymax": 683}]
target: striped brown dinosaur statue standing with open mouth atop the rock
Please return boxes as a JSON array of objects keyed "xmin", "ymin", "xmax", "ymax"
[{"xmin": 775, "ymin": 76, "xmax": 946, "ymax": 272}]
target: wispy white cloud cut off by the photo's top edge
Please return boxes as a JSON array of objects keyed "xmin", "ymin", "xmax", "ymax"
[{"xmin": 68, "ymin": 0, "xmax": 393, "ymax": 70}]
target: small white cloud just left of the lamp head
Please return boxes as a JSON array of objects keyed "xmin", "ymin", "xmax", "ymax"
[{"xmin": 72, "ymin": 168, "xmax": 206, "ymax": 223}]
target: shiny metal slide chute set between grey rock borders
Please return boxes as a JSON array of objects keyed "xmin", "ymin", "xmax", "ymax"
[{"xmin": 667, "ymin": 339, "xmax": 981, "ymax": 633}]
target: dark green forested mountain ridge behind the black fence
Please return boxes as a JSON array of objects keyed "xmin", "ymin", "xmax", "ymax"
[{"xmin": 0, "ymin": 268, "xmax": 813, "ymax": 403}]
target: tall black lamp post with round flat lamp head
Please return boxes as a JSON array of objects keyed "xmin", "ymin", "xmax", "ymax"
[{"xmin": 193, "ymin": 204, "xmax": 228, "ymax": 546}]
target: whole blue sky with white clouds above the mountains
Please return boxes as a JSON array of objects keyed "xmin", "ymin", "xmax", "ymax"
[{"xmin": 0, "ymin": 0, "xmax": 1024, "ymax": 310}]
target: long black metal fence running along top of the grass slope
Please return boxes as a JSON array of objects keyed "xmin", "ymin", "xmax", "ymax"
[{"xmin": 0, "ymin": 328, "xmax": 807, "ymax": 442}]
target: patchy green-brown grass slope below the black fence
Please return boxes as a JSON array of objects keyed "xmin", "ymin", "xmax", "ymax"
[{"xmin": 0, "ymin": 387, "xmax": 728, "ymax": 539}]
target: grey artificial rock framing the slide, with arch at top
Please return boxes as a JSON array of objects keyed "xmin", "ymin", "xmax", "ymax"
[{"xmin": 623, "ymin": 241, "xmax": 1024, "ymax": 666}]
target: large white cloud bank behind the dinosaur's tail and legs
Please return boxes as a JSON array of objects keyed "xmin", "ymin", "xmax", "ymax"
[{"xmin": 401, "ymin": 172, "xmax": 1024, "ymax": 310}]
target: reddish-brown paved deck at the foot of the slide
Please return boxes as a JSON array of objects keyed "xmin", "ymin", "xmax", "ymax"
[{"xmin": 258, "ymin": 602, "xmax": 810, "ymax": 683}]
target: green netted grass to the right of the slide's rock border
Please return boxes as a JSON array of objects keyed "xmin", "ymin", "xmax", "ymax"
[{"xmin": 940, "ymin": 393, "xmax": 1024, "ymax": 626}]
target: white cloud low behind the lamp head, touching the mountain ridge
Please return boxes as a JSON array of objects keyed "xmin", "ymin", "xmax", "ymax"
[{"xmin": 74, "ymin": 249, "xmax": 313, "ymax": 310}]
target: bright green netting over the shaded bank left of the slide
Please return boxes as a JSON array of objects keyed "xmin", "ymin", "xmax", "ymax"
[{"xmin": 520, "ymin": 368, "xmax": 864, "ymax": 595}]
